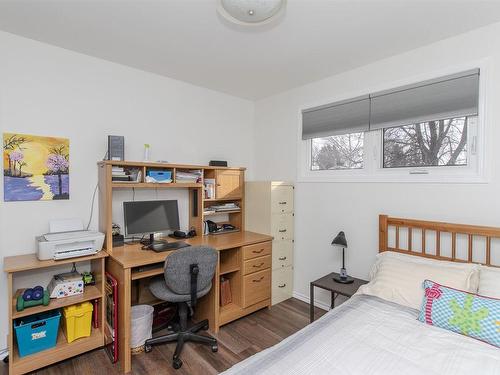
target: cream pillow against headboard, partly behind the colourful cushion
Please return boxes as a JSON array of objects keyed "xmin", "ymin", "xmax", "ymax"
[{"xmin": 358, "ymin": 252, "xmax": 479, "ymax": 310}]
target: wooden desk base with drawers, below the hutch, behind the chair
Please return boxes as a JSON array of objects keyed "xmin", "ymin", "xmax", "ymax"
[{"xmin": 106, "ymin": 231, "xmax": 272, "ymax": 373}]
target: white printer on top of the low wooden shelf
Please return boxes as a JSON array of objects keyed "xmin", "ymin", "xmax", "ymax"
[{"xmin": 36, "ymin": 219, "xmax": 104, "ymax": 260}]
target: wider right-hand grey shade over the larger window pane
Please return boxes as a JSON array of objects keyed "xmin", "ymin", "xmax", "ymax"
[{"xmin": 370, "ymin": 69, "xmax": 479, "ymax": 130}]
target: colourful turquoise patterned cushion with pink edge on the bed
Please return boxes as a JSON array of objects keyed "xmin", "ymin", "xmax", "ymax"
[{"xmin": 418, "ymin": 280, "xmax": 500, "ymax": 348}]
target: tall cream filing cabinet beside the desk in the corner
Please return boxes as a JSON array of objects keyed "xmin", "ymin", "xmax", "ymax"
[{"xmin": 245, "ymin": 181, "xmax": 294, "ymax": 305}]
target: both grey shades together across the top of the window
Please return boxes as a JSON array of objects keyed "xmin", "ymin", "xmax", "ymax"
[{"xmin": 302, "ymin": 69, "xmax": 479, "ymax": 139}]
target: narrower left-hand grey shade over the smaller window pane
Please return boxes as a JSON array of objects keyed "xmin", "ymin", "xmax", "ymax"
[{"xmin": 302, "ymin": 95, "xmax": 370, "ymax": 139}]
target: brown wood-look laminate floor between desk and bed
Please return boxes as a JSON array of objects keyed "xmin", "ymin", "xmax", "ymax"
[{"xmin": 0, "ymin": 298, "xmax": 325, "ymax": 375}]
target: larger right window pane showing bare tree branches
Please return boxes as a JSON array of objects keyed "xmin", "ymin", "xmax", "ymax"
[{"xmin": 383, "ymin": 117, "xmax": 468, "ymax": 168}]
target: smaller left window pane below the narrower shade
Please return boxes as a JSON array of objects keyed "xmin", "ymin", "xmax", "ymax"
[{"xmin": 311, "ymin": 132, "xmax": 364, "ymax": 170}]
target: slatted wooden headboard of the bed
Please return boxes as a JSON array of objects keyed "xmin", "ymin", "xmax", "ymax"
[{"xmin": 379, "ymin": 215, "xmax": 500, "ymax": 267}]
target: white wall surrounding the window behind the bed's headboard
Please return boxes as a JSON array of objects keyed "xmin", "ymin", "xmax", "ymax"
[{"xmin": 254, "ymin": 24, "xmax": 500, "ymax": 303}]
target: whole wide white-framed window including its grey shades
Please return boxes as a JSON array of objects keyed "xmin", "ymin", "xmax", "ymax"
[{"xmin": 299, "ymin": 69, "xmax": 488, "ymax": 183}]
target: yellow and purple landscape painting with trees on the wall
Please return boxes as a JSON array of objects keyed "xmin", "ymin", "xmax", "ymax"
[{"xmin": 3, "ymin": 133, "xmax": 69, "ymax": 202}]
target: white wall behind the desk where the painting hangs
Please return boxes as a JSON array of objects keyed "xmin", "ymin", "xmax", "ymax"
[{"xmin": 0, "ymin": 32, "xmax": 254, "ymax": 349}]
